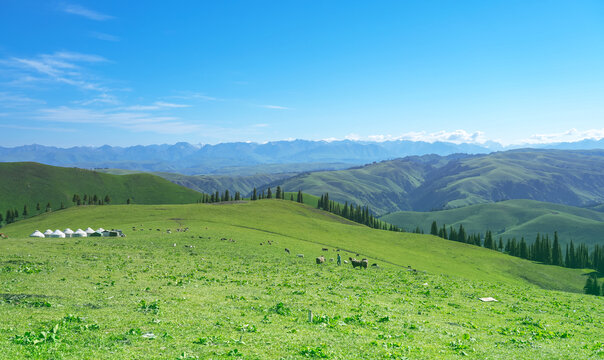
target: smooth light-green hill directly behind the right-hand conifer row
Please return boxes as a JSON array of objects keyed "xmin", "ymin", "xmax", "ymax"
[{"xmin": 380, "ymin": 200, "xmax": 604, "ymax": 245}]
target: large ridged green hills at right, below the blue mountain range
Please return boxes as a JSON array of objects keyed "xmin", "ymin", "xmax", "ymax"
[{"xmin": 271, "ymin": 149, "xmax": 604, "ymax": 214}]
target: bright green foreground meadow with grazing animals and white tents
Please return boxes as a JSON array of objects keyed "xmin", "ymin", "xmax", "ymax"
[{"xmin": 0, "ymin": 200, "xmax": 604, "ymax": 359}]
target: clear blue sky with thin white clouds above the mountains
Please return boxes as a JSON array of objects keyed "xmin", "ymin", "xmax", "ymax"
[{"xmin": 0, "ymin": 0, "xmax": 604, "ymax": 147}]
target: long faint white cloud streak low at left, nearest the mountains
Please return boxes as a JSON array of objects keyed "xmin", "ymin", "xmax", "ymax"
[{"xmin": 35, "ymin": 106, "xmax": 201, "ymax": 134}]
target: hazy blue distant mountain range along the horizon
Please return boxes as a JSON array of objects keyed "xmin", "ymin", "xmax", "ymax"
[{"xmin": 0, "ymin": 139, "xmax": 604, "ymax": 175}]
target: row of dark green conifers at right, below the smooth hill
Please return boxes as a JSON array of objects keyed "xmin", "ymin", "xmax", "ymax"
[{"xmin": 430, "ymin": 221, "xmax": 604, "ymax": 295}]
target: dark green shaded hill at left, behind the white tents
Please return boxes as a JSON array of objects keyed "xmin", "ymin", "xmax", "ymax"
[{"xmin": 0, "ymin": 163, "xmax": 200, "ymax": 215}]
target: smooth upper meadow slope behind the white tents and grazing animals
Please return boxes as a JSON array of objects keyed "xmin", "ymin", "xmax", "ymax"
[{"xmin": 3, "ymin": 200, "xmax": 583, "ymax": 291}]
